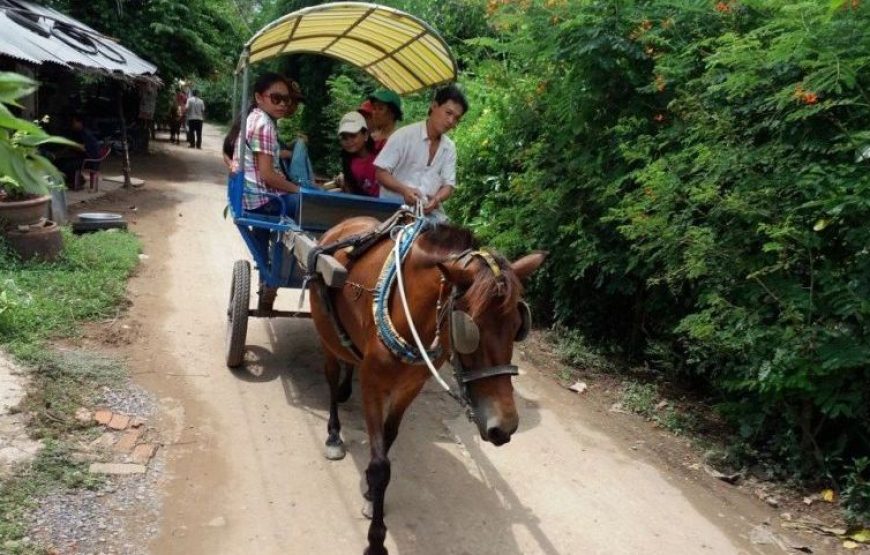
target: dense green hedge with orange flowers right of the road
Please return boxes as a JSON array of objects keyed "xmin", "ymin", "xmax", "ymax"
[{"xmin": 449, "ymin": 0, "xmax": 870, "ymax": 514}]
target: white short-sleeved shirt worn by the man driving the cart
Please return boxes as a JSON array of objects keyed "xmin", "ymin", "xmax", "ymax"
[{"xmin": 375, "ymin": 121, "xmax": 456, "ymax": 214}]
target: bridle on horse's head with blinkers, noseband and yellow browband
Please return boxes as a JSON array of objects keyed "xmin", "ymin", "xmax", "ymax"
[{"xmin": 448, "ymin": 250, "xmax": 531, "ymax": 410}]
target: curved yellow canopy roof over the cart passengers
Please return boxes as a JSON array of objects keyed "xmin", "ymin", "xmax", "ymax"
[{"xmin": 240, "ymin": 2, "xmax": 456, "ymax": 94}]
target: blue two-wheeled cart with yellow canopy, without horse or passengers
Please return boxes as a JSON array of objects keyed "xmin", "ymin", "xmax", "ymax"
[{"xmin": 226, "ymin": 2, "xmax": 456, "ymax": 368}]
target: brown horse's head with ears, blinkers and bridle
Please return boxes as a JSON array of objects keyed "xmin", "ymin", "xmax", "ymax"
[{"xmin": 439, "ymin": 251, "xmax": 546, "ymax": 445}]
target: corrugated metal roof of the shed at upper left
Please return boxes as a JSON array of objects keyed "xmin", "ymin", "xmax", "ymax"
[{"xmin": 0, "ymin": 0, "xmax": 157, "ymax": 80}]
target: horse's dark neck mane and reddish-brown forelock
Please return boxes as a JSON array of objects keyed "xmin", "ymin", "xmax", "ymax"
[{"xmin": 419, "ymin": 224, "xmax": 523, "ymax": 317}]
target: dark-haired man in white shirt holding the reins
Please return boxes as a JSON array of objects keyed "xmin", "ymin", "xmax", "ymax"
[{"xmin": 375, "ymin": 85, "xmax": 468, "ymax": 219}]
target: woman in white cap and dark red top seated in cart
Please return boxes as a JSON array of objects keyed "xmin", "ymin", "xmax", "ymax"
[{"xmin": 338, "ymin": 110, "xmax": 381, "ymax": 197}]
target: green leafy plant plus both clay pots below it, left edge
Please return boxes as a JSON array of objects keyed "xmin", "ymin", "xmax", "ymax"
[{"xmin": 0, "ymin": 72, "xmax": 79, "ymax": 260}]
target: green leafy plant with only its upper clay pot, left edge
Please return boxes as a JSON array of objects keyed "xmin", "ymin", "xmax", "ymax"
[{"xmin": 0, "ymin": 72, "xmax": 79, "ymax": 228}]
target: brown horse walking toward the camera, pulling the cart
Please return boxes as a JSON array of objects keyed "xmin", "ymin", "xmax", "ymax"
[{"xmin": 311, "ymin": 218, "xmax": 545, "ymax": 555}]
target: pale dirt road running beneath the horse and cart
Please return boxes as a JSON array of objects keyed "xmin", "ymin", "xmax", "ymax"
[{"xmin": 105, "ymin": 127, "xmax": 782, "ymax": 555}]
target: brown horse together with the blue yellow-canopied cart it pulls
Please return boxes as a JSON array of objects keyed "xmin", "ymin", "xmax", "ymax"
[{"xmin": 226, "ymin": 2, "xmax": 545, "ymax": 555}]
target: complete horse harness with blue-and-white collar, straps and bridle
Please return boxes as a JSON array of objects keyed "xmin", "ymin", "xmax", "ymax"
[{"xmin": 303, "ymin": 210, "xmax": 531, "ymax": 417}]
